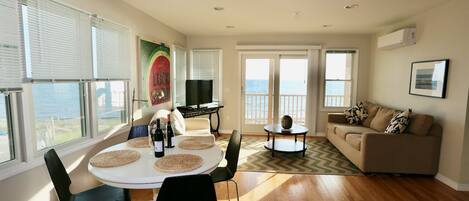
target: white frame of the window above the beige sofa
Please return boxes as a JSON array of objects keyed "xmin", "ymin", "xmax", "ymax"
[{"xmin": 319, "ymin": 48, "xmax": 360, "ymax": 112}]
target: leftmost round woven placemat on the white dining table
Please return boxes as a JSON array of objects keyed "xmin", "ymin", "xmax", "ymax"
[{"xmin": 90, "ymin": 150, "xmax": 140, "ymax": 168}]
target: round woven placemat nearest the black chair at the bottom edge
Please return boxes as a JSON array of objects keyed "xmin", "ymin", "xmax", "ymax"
[{"xmin": 155, "ymin": 154, "xmax": 204, "ymax": 173}]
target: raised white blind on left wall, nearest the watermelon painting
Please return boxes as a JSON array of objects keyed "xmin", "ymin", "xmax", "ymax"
[{"xmin": 92, "ymin": 18, "xmax": 130, "ymax": 79}]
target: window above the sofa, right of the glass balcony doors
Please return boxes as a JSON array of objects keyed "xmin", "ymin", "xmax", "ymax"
[{"xmin": 323, "ymin": 50, "xmax": 356, "ymax": 108}]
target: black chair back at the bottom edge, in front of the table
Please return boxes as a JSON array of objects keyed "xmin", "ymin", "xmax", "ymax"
[{"xmin": 156, "ymin": 174, "xmax": 217, "ymax": 201}]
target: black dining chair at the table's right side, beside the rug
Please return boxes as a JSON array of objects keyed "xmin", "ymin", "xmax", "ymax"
[{"xmin": 210, "ymin": 130, "xmax": 242, "ymax": 201}]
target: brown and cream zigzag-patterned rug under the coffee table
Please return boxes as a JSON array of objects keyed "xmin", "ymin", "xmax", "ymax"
[{"xmin": 216, "ymin": 135, "xmax": 363, "ymax": 175}]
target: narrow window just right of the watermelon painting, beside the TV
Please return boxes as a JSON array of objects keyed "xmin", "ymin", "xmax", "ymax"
[{"xmin": 173, "ymin": 47, "xmax": 186, "ymax": 106}]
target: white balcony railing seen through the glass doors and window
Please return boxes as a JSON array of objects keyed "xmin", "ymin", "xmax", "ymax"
[{"xmin": 244, "ymin": 94, "xmax": 344, "ymax": 125}]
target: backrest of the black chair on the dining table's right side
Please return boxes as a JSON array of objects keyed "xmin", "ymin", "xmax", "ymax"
[{"xmin": 225, "ymin": 130, "xmax": 242, "ymax": 179}]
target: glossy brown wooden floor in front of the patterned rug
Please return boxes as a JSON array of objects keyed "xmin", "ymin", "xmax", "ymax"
[{"xmin": 131, "ymin": 172, "xmax": 469, "ymax": 201}]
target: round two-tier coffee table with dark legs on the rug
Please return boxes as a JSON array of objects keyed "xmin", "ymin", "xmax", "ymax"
[{"xmin": 264, "ymin": 124, "xmax": 309, "ymax": 157}]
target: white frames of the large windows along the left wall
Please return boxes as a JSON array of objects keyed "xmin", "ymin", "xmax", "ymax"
[{"xmin": 0, "ymin": 0, "xmax": 134, "ymax": 181}]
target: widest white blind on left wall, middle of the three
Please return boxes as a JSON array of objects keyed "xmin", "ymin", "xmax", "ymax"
[{"xmin": 22, "ymin": 0, "xmax": 92, "ymax": 80}]
